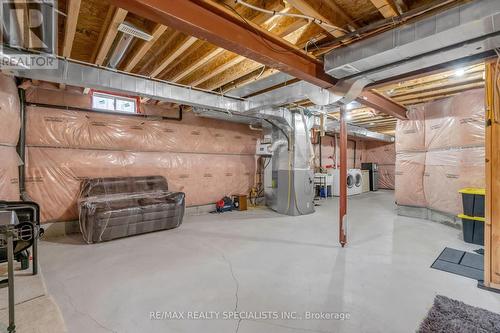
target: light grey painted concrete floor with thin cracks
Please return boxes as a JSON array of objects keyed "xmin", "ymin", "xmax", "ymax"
[{"xmin": 40, "ymin": 191, "xmax": 500, "ymax": 333}]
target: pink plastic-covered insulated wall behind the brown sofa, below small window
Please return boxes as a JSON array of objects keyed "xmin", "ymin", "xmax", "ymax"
[{"xmin": 26, "ymin": 89, "xmax": 260, "ymax": 222}]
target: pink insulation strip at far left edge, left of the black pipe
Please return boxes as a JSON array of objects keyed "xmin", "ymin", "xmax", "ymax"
[{"xmin": 0, "ymin": 74, "xmax": 20, "ymax": 201}]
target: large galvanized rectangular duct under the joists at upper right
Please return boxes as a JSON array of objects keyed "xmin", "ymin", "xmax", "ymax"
[{"xmin": 325, "ymin": 0, "xmax": 500, "ymax": 79}]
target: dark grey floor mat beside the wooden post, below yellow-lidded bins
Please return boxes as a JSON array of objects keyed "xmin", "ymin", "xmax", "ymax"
[{"xmin": 431, "ymin": 247, "xmax": 484, "ymax": 280}]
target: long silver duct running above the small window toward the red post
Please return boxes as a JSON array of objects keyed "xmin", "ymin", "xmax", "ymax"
[{"xmin": 0, "ymin": 46, "xmax": 338, "ymax": 113}]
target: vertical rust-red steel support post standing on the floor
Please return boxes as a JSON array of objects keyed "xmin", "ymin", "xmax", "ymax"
[{"xmin": 339, "ymin": 105, "xmax": 347, "ymax": 247}]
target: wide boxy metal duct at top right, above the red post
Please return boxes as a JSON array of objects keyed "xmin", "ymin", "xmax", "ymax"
[{"xmin": 325, "ymin": 0, "xmax": 500, "ymax": 82}]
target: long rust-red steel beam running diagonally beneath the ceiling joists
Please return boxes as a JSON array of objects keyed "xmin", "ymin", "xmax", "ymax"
[{"xmin": 111, "ymin": 0, "xmax": 406, "ymax": 119}]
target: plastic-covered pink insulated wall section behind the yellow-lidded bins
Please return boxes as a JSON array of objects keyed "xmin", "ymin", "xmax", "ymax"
[{"xmin": 396, "ymin": 89, "xmax": 485, "ymax": 215}]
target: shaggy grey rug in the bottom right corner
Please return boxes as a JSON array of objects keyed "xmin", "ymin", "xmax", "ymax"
[{"xmin": 417, "ymin": 295, "xmax": 500, "ymax": 333}]
